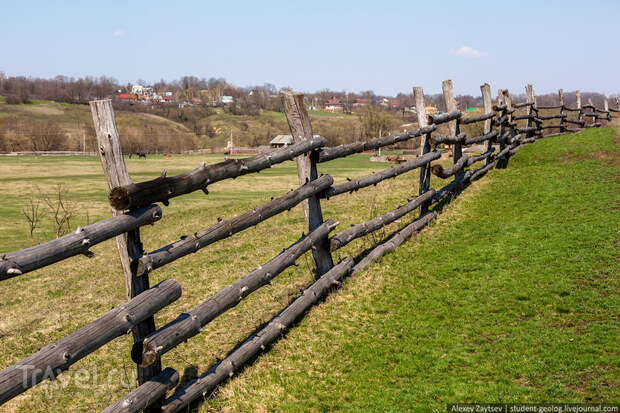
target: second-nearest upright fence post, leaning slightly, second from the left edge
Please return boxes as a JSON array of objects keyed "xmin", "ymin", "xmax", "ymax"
[{"xmin": 281, "ymin": 92, "xmax": 334, "ymax": 278}]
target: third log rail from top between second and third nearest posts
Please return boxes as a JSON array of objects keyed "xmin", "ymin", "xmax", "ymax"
[{"xmin": 330, "ymin": 189, "xmax": 435, "ymax": 251}]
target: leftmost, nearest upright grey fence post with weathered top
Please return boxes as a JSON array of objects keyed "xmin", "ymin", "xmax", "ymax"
[{"xmin": 90, "ymin": 99, "xmax": 161, "ymax": 412}]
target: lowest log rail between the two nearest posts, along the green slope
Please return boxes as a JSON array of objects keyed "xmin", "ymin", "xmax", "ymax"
[{"xmin": 162, "ymin": 257, "xmax": 353, "ymax": 413}]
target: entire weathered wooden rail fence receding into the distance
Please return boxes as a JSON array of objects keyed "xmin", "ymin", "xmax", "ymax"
[{"xmin": 0, "ymin": 80, "xmax": 620, "ymax": 412}]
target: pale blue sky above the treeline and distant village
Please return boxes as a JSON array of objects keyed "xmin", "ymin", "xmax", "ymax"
[{"xmin": 0, "ymin": 0, "xmax": 620, "ymax": 95}]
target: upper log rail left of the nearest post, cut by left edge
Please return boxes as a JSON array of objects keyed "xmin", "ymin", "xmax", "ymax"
[{"xmin": 0, "ymin": 205, "xmax": 161, "ymax": 280}]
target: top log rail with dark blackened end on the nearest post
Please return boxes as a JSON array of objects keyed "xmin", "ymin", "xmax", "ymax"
[{"xmin": 109, "ymin": 137, "xmax": 325, "ymax": 210}]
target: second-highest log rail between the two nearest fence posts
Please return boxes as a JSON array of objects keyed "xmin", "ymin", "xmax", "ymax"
[{"xmin": 137, "ymin": 175, "xmax": 334, "ymax": 275}]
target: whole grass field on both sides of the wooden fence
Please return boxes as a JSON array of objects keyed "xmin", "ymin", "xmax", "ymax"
[{"xmin": 0, "ymin": 127, "xmax": 620, "ymax": 412}]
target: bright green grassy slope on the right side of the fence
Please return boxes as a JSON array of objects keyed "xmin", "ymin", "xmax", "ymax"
[{"xmin": 209, "ymin": 128, "xmax": 620, "ymax": 411}]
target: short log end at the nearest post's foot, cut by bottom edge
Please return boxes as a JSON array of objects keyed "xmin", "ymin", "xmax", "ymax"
[{"xmin": 102, "ymin": 367, "xmax": 179, "ymax": 413}]
